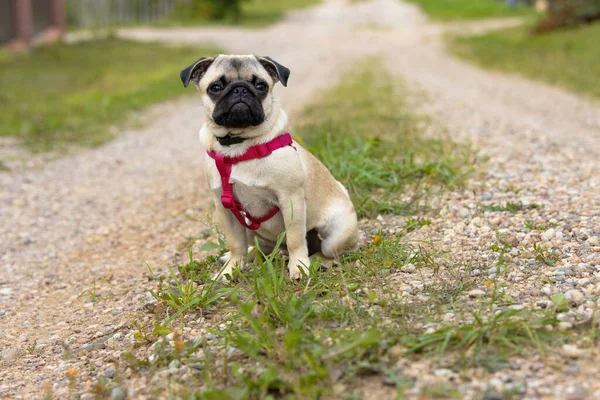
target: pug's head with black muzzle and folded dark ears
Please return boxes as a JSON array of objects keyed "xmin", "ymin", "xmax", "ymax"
[{"xmin": 180, "ymin": 55, "xmax": 290, "ymax": 130}]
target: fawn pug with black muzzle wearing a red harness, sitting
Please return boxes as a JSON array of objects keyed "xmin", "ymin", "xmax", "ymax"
[{"xmin": 180, "ymin": 55, "xmax": 358, "ymax": 279}]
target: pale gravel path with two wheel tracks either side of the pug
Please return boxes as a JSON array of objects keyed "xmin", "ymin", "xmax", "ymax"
[{"xmin": 0, "ymin": 0, "xmax": 600, "ymax": 398}]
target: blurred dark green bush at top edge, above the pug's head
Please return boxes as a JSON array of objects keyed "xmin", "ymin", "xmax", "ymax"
[{"xmin": 176, "ymin": 0, "xmax": 246, "ymax": 21}]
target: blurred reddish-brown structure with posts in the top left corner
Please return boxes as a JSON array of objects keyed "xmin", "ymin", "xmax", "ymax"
[{"xmin": 0, "ymin": 0, "xmax": 67, "ymax": 49}]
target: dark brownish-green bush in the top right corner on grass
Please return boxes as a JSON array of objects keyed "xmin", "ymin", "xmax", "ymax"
[{"xmin": 533, "ymin": 0, "xmax": 600, "ymax": 33}]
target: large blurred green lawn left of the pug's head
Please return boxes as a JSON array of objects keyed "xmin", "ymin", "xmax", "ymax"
[{"xmin": 0, "ymin": 39, "xmax": 218, "ymax": 151}]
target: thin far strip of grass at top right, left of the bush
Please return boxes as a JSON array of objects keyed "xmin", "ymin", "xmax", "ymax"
[{"xmin": 410, "ymin": 0, "xmax": 534, "ymax": 21}]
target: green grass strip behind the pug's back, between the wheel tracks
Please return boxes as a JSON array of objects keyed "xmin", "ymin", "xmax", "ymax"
[{"xmin": 293, "ymin": 63, "xmax": 473, "ymax": 217}]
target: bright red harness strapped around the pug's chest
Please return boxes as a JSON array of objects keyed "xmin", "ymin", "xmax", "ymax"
[{"xmin": 206, "ymin": 133, "xmax": 295, "ymax": 231}]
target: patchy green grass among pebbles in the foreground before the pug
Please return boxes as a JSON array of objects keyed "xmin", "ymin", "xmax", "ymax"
[{"xmin": 132, "ymin": 228, "xmax": 593, "ymax": 399}]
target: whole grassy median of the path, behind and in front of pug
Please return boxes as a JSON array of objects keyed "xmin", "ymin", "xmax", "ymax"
[{"xmin": 98, "ymin": 64, "xmax": 595, "ymax": 399}]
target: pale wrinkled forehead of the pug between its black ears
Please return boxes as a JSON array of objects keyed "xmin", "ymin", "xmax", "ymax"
[{"xmin": 206, "ymin": 55, "xmax": 268, "ymax": 82}]
